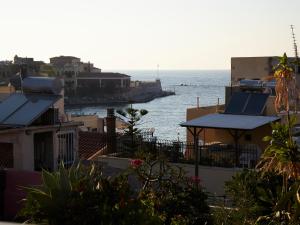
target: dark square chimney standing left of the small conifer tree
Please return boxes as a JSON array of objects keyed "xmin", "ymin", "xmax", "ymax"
[{"xmin": 106, "ymin": 108, "xmax": 116, "ymax": 153}]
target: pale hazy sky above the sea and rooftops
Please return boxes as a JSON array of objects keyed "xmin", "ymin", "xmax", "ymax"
[{"xmin": 0, "ymin": 0, "xmax": 300, "ymax": 70}]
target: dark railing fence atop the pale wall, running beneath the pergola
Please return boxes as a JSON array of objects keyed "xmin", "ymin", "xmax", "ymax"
[{"xmin": 115, "ymin": 136, "xmax": 260, "ymax": 168}]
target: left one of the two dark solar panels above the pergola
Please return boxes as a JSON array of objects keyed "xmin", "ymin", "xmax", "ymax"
[{"xmin": 224, "ymin": 92, "xmax": 250, "ymax": 114}]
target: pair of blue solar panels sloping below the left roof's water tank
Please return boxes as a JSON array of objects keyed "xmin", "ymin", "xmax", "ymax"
[{"xmin": 0, "ymin": 94, "xmax": 60, "ymax": 126}]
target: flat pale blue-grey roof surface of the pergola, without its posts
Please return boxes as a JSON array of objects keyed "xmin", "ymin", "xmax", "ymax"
[{"xmin": 180, "ymin": 113, "xmax": 280, "ymax": 130}]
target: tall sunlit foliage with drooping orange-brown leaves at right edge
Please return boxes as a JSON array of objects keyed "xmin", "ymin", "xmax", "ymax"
[{"xmin": 257, "ymin": 117, "xmax": 300, "ymax": 224}]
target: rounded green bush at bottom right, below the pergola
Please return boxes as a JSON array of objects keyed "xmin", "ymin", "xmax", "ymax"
[{"xmin": 225, "ymin": 170, "xmax": 282, "ymax": 224}]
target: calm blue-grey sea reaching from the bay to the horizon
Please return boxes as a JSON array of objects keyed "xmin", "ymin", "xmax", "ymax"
[{"xmin": 66, "ymin": 70, "xmax": 230, "ymax": 141}]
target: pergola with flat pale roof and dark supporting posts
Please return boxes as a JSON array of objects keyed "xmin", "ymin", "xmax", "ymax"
[{"xmin": 180, "ymin": 113, "xmax": 280, "ymax": 176}]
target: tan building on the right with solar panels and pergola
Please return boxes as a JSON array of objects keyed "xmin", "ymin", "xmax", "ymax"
[{"xmin": 181, "ymin": 57, "xmax": 300, "ymax": 167}]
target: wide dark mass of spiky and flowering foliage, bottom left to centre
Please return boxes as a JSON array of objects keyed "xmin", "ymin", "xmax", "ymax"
[{"xmin": 20, "ymin": 156, "xmax": 209, "ymax": 225}]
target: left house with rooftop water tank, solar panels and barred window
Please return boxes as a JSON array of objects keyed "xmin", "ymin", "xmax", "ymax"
[{"xmin": 0, "ymin": 77, "xmax": 82, "ymax": 171}]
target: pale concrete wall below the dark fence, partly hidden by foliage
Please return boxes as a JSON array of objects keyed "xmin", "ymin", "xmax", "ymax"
[{"xmin": 97, "ymin": 156, "xmax": 241, "ymax": 195}]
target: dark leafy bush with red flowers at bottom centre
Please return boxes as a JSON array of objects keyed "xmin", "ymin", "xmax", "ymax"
[{"xmin": 132, "ymin": 155, "xmax": 211, "ymax": 225}]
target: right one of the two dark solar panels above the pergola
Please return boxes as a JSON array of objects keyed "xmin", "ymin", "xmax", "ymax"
[{"xmin": 243, "ymin": 93, "xmax": 269, "ymax": 115}]
